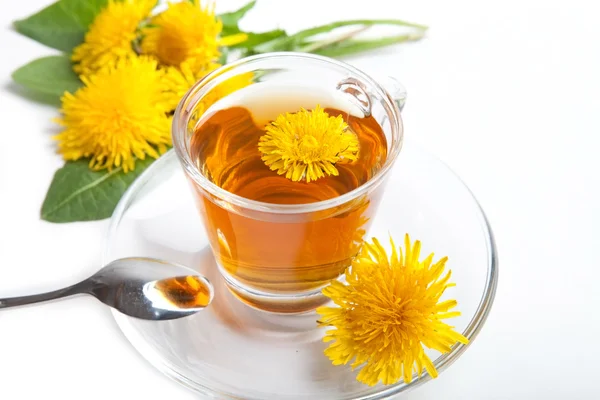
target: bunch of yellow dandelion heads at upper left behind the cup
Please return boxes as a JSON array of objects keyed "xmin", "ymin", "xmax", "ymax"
[{"xmin": 55, "ymin": 0, "xmax": 251, "ymax": 172}]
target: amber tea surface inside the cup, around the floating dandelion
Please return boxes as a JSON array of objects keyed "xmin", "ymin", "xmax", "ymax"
[{"xmin": 191, "ymin": 107, "xmax": 387, "ymax": 204}]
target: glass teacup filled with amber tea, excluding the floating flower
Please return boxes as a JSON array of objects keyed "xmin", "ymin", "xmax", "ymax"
[{"xmin": 173, "ymin": 53, "xmax": 406, "ymax": 313}]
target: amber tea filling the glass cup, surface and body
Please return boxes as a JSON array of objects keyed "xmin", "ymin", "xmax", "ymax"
[{"xmin": 190, "ymin": 86, "xmax": 387, "ymax": 308}]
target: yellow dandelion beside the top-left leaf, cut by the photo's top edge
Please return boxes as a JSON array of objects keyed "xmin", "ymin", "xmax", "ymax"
[{"xmin": 71, "ymin": 0, "xmax": 156, "ymax": 75}]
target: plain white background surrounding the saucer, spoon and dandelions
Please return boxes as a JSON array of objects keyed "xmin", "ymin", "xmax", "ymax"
[{"xmin": 0, "ymin": 0, "xmax": 600, "ymax": 400}]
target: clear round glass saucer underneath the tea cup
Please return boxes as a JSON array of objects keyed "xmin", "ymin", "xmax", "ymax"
[{"xmin": 102, "ymin": 144, "xmax": 498, "ymax": 400}]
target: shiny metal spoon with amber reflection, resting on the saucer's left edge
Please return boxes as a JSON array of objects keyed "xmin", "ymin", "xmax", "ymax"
[{"xmin": 0, "ymin": 258, "xmax": 214, "ymax": 321}]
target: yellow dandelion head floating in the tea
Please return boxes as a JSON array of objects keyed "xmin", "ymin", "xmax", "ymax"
[{"xmin": 258, "ymin": 105, "xmax": 358, "ymax": 182}]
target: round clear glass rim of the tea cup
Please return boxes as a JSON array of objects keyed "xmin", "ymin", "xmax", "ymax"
[{"xmin": 171, "ymin": 52, "xmax": 403, "ymax": 214}]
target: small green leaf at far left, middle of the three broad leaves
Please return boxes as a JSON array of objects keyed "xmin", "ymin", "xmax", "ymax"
[{"xmin": 12, "ymin": 55, "xmax": 83, "ymax": 97}]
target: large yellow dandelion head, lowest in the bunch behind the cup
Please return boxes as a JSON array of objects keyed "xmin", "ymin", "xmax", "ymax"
[{"xmin": 55, "ymin": 57, "xmax": 171, "ymax": 172}]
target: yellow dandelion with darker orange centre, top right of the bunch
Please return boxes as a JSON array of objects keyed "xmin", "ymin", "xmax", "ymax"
[{"xmin": 141, "ymin": 0, "xmax": 246, "ymax": 70}]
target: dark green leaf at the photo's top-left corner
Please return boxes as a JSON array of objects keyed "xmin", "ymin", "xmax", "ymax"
[{"xmin": 14, "ymin": 0, "xmax": 108, "ymax": 52}]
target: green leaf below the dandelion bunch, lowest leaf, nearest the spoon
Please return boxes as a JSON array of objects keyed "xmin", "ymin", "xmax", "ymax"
[{"xmin": 41, "ymin": 157, "xmax": 155, "ymax": 223}]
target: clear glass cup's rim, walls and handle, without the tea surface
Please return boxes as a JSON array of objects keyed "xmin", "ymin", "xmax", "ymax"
[{"xmin": 173, "ymin": 52, "xmax": 406, "ymax": 313}]
